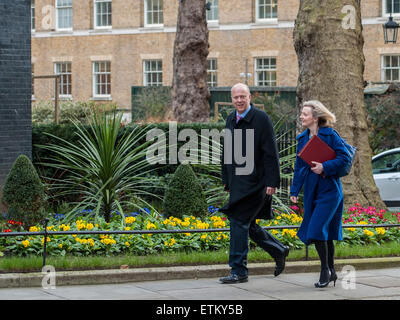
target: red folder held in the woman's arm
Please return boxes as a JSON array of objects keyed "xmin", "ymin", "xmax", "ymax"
[{"xmin": 299, "ymin": 135, "xmax": 336, "ymax": 167}]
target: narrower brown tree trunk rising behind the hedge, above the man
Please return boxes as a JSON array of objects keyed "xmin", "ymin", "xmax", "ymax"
[{"xmin": 171, "ymin": 0, "xmax": 210, "ymax": 122}]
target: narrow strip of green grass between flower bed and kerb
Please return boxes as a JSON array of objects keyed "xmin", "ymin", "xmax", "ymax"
[{"xmin": 0, "ymin": 242, "xmax": 400, "ymax": 272}]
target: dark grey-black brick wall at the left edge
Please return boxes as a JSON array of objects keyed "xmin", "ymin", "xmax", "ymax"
[{"xmin": 0, "ymin": 0, "xmax": 32, "ymax": 195}]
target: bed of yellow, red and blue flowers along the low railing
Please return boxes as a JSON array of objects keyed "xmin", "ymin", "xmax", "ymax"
[{"xmin": 0, "ymin": 204, "xmax": 400, "ymax": 256}]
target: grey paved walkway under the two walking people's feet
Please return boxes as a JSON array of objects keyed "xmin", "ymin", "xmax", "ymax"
[{"xmin": 0, "ymin": 267, "xmax": 400, "ymax": 300}]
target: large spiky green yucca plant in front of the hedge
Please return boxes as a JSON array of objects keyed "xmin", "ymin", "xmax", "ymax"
[{"xmin": 39, "ymin": 109, "xmax": 160, "ymax": 222}]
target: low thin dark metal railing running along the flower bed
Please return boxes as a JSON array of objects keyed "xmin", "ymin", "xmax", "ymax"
[{"xmin": 0, "ymin": 219, "xmax": 400, "ymax": 266}]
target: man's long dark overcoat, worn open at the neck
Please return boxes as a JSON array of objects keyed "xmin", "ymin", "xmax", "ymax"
[{"xmin": 220, "ymin": 106, "xmax": 280, "ymax": 221}]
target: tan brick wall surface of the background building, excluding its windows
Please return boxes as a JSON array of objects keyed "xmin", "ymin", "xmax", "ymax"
[{"xmin": 32, "ymin": 0, "xmax": 400, "ymax": 109}]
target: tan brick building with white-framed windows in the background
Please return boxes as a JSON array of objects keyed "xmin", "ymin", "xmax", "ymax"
[{"xmin": 32, "ymin": 0, "xmax": 400, "ymax": 109}]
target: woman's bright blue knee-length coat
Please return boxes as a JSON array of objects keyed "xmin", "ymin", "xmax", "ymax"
[{"xmin": 290, "ymin": 127, "xmax": 348, "ymax": 244}]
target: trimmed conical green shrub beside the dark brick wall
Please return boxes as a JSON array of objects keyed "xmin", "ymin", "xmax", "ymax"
[{"xmin": 2, "ymin": 155, "xmax": 46, "ymax": 228}]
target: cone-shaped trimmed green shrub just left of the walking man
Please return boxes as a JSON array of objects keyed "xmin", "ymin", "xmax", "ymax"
[{"xmin": 163, "ymin": 164, "xmax": 207, "ymax": 218}]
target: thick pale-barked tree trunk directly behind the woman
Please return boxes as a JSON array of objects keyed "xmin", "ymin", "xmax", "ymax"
[{"xmin": 293, "ymin": 0, "xmax": 386, "ymax": 209}]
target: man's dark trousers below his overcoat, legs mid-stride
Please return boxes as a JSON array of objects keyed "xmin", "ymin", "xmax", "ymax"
[{"xmin": 229, "ymin": 218, "xmax": 285, "ymax": 276}]
